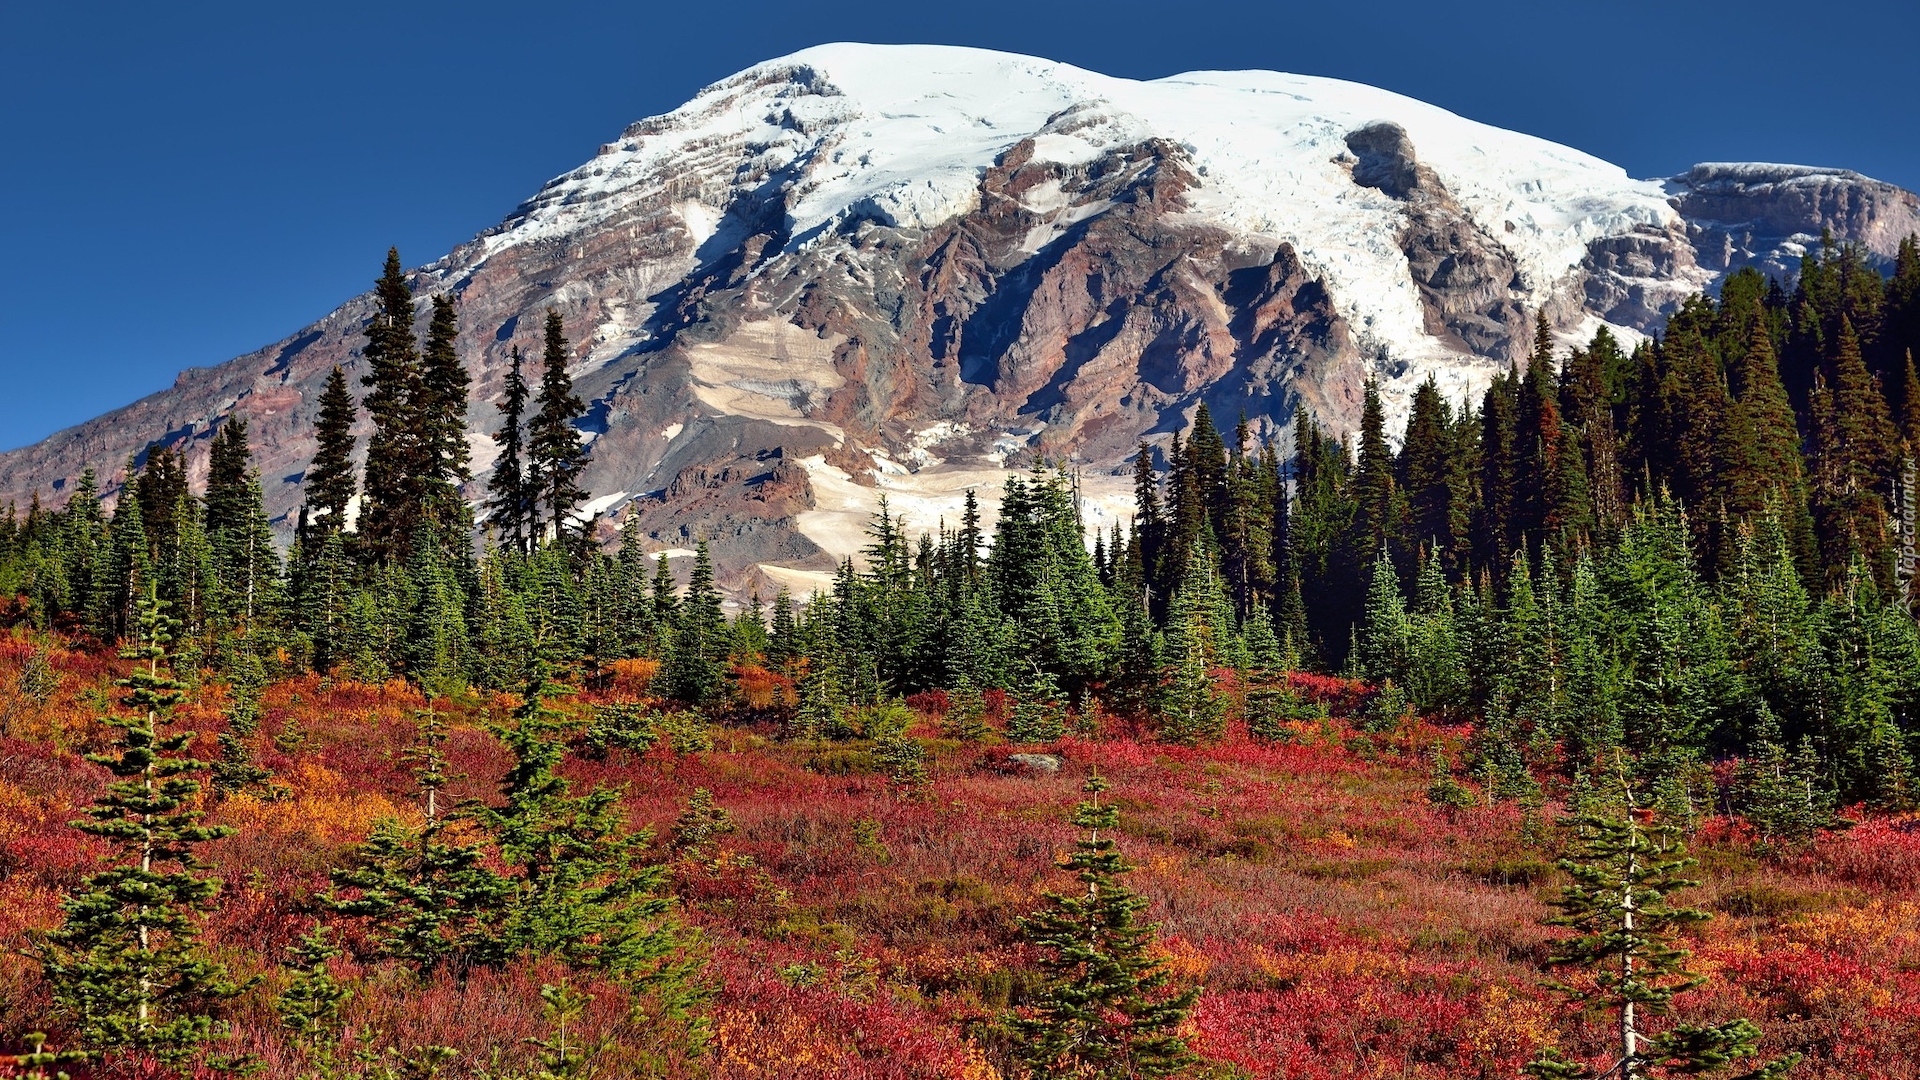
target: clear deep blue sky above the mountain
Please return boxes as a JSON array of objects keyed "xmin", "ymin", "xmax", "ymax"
[{"xmin": 0, "ymin": 0, "xmax": 1920, "ymax": 448}]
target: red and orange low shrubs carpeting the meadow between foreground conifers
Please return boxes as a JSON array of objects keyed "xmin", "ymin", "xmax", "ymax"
[{"xmin": 0, "ymin": 634, "xmax": 1920, "ymax": 1080}]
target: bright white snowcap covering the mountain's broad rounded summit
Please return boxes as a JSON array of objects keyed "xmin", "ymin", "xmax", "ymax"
[{"xmin": 486, "ymin": 44, "xmax": 1678, "ymax": 399}]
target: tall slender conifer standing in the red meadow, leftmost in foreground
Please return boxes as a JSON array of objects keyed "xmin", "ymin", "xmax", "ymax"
[{"xmin": 42, "ymin": 586, "xmax": 242, "ymax": 1067}]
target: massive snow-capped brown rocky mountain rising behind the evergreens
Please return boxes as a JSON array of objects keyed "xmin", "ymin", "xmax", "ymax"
[{"xmin": 0, "ymin": 46, "xmax": 1920, "ymax": 592}]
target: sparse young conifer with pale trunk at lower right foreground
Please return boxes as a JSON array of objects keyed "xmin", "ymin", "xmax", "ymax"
[{"xmin": 1526, "ymin": 780, "xmax": 1799, "ymax": 1080}]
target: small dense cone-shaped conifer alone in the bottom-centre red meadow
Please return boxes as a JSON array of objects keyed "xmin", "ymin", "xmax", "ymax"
[{"xmin": 1014, "ymin": 776, "xmax": 1198, "ymax": 1080}]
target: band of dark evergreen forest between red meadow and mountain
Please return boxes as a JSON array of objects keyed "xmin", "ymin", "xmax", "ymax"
[{"xmin": 0, "ymin": 240, "xmax": 1920, "ymax": 801}]
